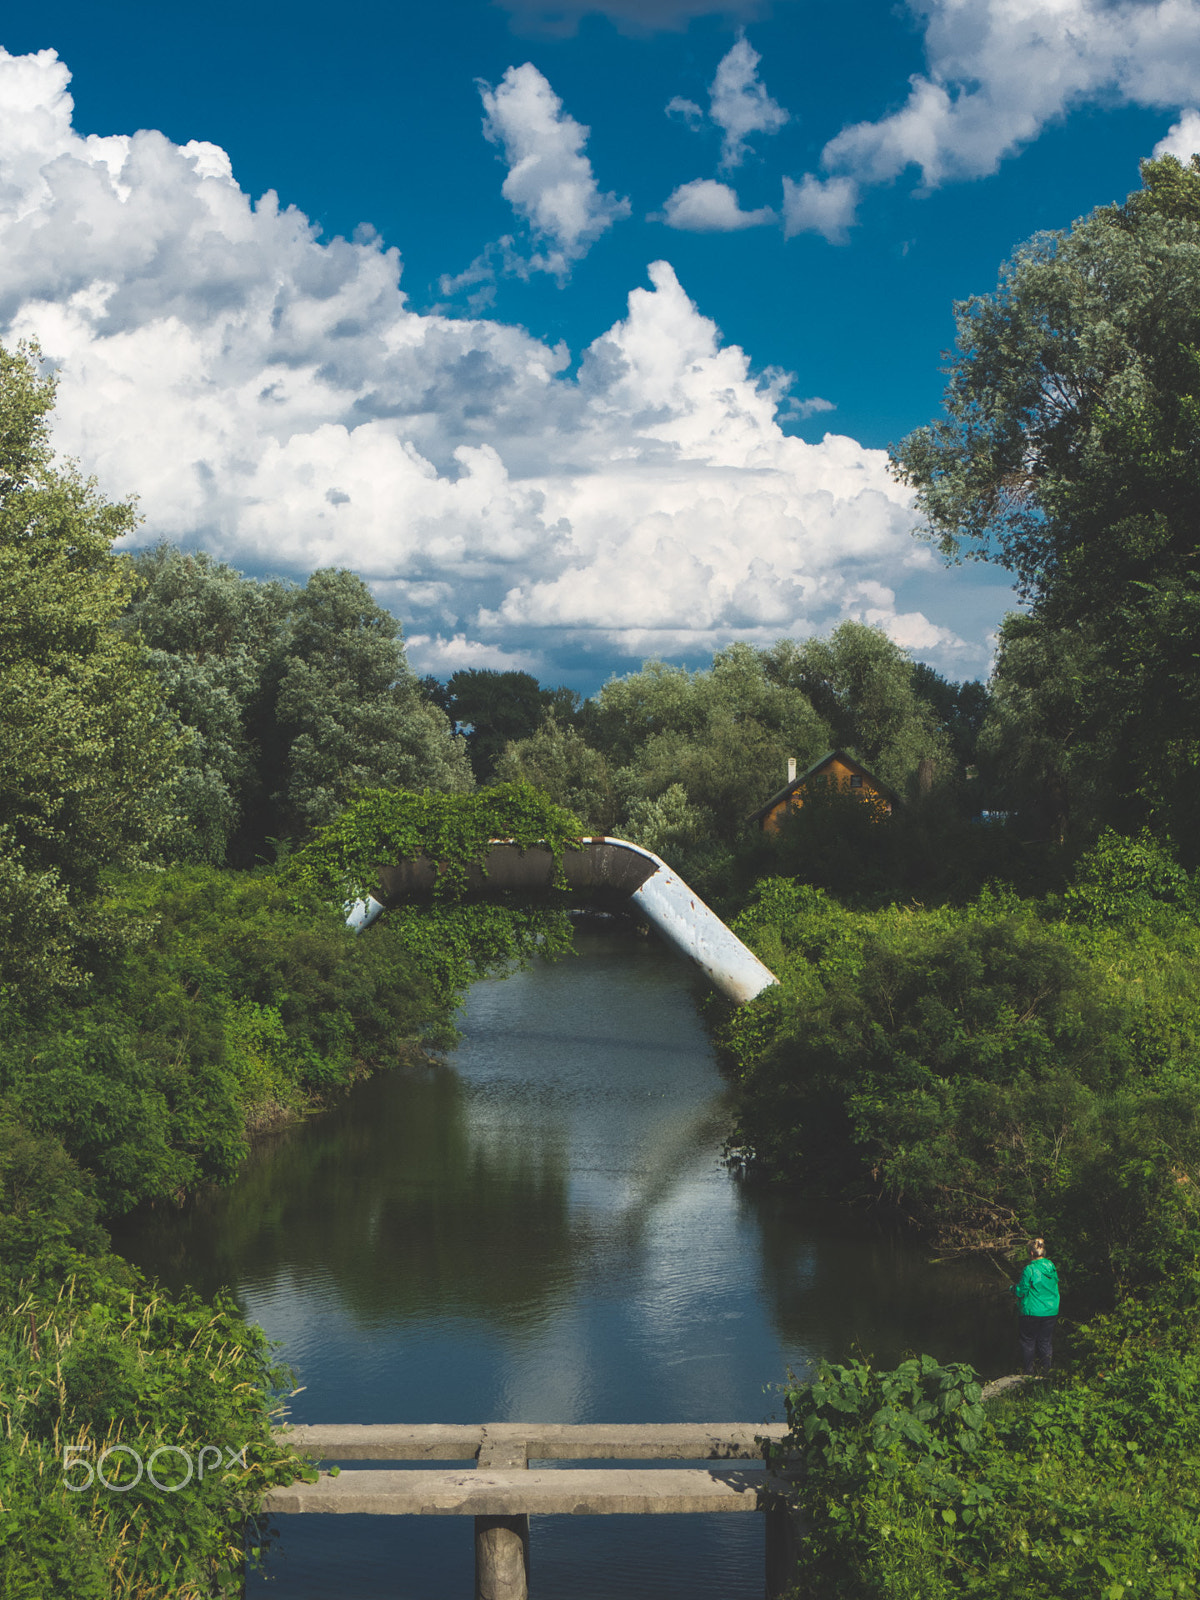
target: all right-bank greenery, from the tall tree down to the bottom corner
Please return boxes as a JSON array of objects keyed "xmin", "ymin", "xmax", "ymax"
[{"xmin": 725, "ymin": 157, "xmax": 1200, "ymax": 1600}]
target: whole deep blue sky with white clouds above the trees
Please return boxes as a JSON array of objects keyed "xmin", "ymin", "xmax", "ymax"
[{"xmin": 9, "ymin": 0, "xmax": 1200, "ymax": 688}]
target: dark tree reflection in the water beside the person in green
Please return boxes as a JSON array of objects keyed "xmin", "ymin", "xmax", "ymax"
[{"xmin": 739, "ymin": 1184, "xmax": 1014, "ymax": 1374}]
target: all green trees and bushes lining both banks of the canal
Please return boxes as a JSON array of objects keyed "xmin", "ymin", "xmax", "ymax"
[{"xmin": 0, "ymin": 158, "xmax": 1200, "ymax": 1600}]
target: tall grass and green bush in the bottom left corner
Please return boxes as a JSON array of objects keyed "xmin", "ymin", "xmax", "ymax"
[{"xmin": 0, "ymin": 1258, "xmax": 310, "ymax": 1600}]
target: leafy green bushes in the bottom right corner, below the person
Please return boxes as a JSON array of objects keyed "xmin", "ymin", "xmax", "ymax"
[{"xmin": 779, "ymin": 1262, "xmax": 1200, "ymax": 1600}]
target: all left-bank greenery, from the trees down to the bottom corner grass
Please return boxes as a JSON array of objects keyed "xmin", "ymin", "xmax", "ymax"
[{"xmin": 0, "ymin": 350, "xmax": 579, "ymax": 1600}]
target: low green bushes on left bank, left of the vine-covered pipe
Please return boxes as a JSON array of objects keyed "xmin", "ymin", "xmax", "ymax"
[{"xmin": 0, "ymin": 867, "xmax": 454, "ymax": 1214}]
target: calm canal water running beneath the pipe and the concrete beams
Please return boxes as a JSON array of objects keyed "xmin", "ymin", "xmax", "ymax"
[{"xmin": 115, "ymin": 918, "xmax": 1013, "ymax": 1600}]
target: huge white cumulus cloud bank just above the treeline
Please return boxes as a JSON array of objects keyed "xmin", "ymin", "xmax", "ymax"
[{"xmin": 0, "ymin": 51, "xmax": 982, "ymax": 672}]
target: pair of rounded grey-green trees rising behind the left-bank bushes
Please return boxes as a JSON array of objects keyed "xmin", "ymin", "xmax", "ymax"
[{"xmin": 123, "ymin": 544, "xmax": 472, "ymax": 866}]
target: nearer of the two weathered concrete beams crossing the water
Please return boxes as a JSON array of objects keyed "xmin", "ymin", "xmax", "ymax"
[{"xmin": 262, "ymin": 1467, "xmax": 771, "ymax": 1517}]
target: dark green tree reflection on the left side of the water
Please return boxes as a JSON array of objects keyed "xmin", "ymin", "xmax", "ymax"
[{"xmin": 114, "ymin": 1069, "xmax": 586, "ymax": 1325}]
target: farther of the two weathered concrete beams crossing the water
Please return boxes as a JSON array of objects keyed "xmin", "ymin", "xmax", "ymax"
[{"xmin": 278, "ymin": 1422, "xmax": 787, "ymax": 1461}]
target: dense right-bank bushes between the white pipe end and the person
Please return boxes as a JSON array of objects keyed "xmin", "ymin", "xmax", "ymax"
[{"xmin": 722, "ymin": 837, "xmax": 1200, "ymax": 1293}]
